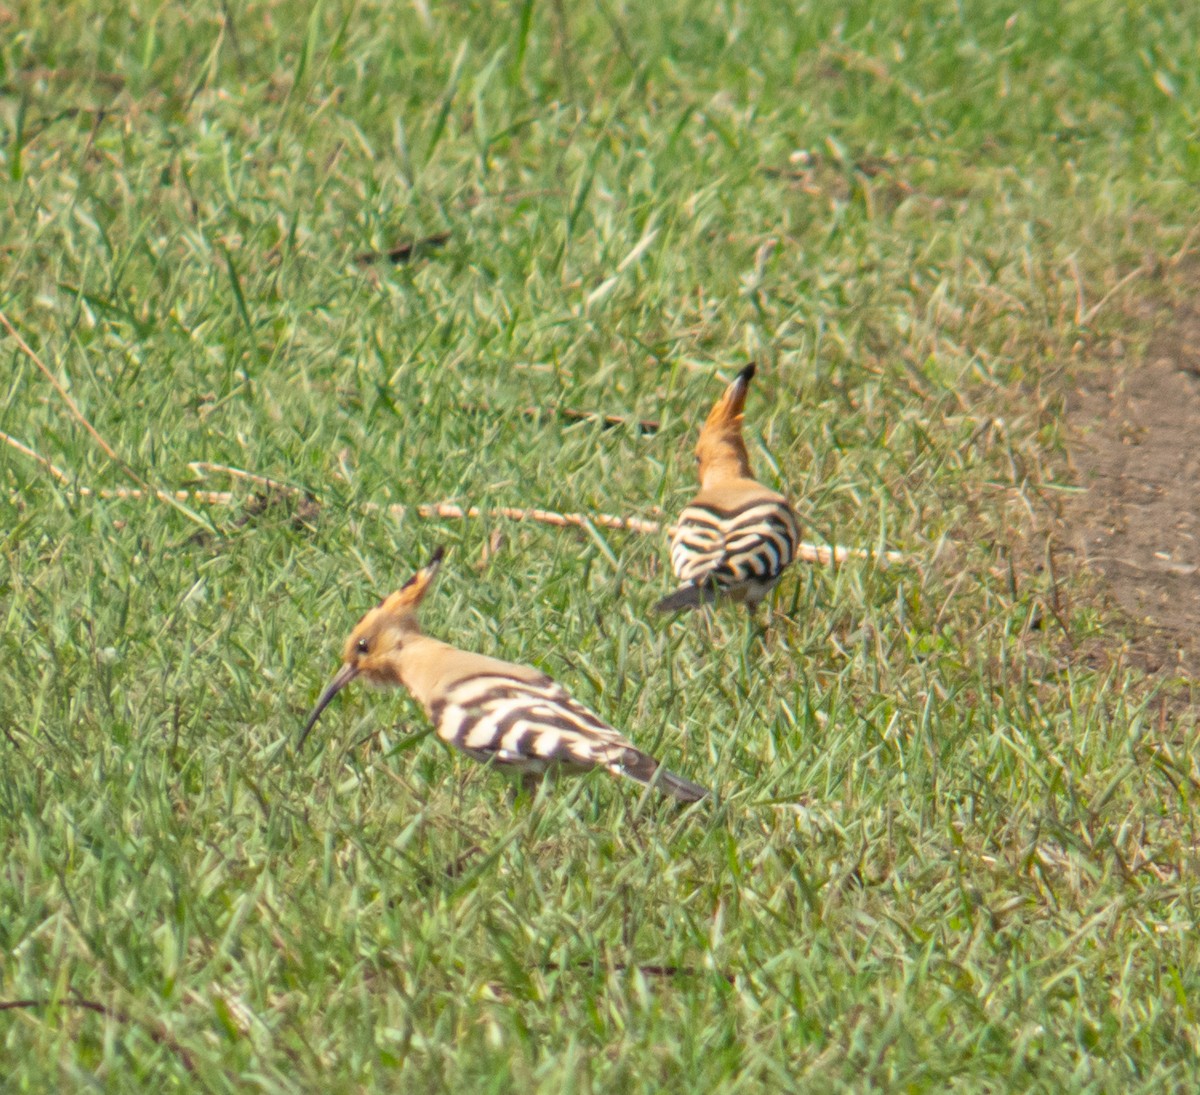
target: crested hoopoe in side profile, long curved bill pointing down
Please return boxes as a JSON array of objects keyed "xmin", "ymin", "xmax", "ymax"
[{"xmin": 296, "ymin": 548, "xmax": 708, "ymax": 802}]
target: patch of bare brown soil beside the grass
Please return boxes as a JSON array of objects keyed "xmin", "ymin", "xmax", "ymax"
[{"xmin": 1062, "ymin": 295, "xmax": 1200, "ymax": 678}]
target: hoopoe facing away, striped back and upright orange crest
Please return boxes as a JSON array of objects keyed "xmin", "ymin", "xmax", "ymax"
[{"xmin": 655, "ymin": 363, "xmax": 800, "ymax": 612}]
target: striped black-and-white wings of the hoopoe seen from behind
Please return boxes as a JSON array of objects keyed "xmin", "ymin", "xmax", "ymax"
[{"xmin": 671, "ymin": 498, "xmax": 800, "ymax": 590}]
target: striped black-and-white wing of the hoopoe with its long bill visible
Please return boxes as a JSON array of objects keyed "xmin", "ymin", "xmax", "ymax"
[{"xmin": 430, "ymin": 674, "xmax": 653, "ymax": 778}]
